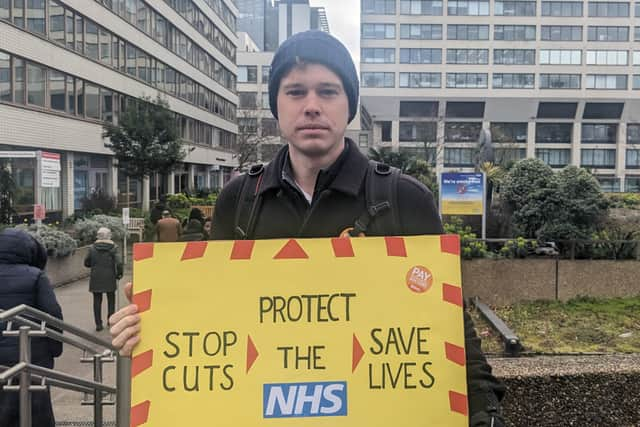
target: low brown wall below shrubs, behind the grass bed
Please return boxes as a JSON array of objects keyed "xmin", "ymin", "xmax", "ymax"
[{"xmin": 462, "ymin": 258, "xmax": 640, "ymax": 306}]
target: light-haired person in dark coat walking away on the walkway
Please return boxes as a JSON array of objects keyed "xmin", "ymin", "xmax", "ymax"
[{"xmin": 84, "ymin": 227, "xmax": 122, "ymax": 331}]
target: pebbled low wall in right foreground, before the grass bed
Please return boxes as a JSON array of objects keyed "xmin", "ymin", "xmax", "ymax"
[{"xmin": 490, "ymin": 354, "xmax": 640, "ymax": 427}]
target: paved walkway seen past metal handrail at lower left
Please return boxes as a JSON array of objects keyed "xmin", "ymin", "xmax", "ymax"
[{"xmin": 52, "ymin": 262, "xmax": 131, "ymax": 426}]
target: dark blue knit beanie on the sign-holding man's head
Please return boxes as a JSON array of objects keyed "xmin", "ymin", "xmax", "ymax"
[{"xmin": 269, "ymin": 30, "xmax": 360, "ymax": 123}]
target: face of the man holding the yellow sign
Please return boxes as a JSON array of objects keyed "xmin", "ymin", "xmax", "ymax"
[{"xmin": 278, "ymin": 64, "xmax": 349, "ymax": 158}]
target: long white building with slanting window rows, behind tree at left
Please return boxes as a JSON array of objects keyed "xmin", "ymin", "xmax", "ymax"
[{"xmin": 0, "ymin": 0, "xmax": 238, "ymax": 216}]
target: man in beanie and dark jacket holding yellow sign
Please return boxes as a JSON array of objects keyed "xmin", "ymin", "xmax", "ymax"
[{"xmin": 112, "ymin": 31, "xmax": 504, "ymax": 427}]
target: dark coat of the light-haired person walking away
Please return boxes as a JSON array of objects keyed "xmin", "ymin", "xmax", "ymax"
[{"xmin": 84, "ymin": 240, "xmax": 122, "ymax": 292}]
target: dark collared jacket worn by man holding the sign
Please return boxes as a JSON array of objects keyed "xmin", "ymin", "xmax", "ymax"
[{"xmin": 212, "ymin": 139, "xmax": 504, "ymax": 427}]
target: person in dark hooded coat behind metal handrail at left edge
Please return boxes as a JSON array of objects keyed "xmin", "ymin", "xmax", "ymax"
[{"xmin": 0, "ymin": 228, "xmax": 62, "ymax": 427}]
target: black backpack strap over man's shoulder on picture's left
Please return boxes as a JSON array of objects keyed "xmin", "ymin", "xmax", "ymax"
[{"xmin": 234, "ymin": 164, "xmax": 264, "ymax": 240}]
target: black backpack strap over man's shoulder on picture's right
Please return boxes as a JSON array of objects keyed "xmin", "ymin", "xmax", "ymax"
[{"xmin": 349, "ymin": 160, "xmax": 400, "ymax": 236}]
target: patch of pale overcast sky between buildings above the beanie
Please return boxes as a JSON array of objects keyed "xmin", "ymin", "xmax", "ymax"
[{"xmin": 310, "ymin": 0, "xmax": 360, "ymax": 68}]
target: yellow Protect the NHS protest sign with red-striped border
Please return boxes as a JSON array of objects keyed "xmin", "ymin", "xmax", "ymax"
[{"xmin": 131, "ymin": 235, "xmax": 468, "ymax": 427}]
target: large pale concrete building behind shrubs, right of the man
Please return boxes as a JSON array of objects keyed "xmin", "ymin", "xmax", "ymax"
[{"xmin": 360, "ymin": 0, "xmax": 640, "ymax": 192}]
